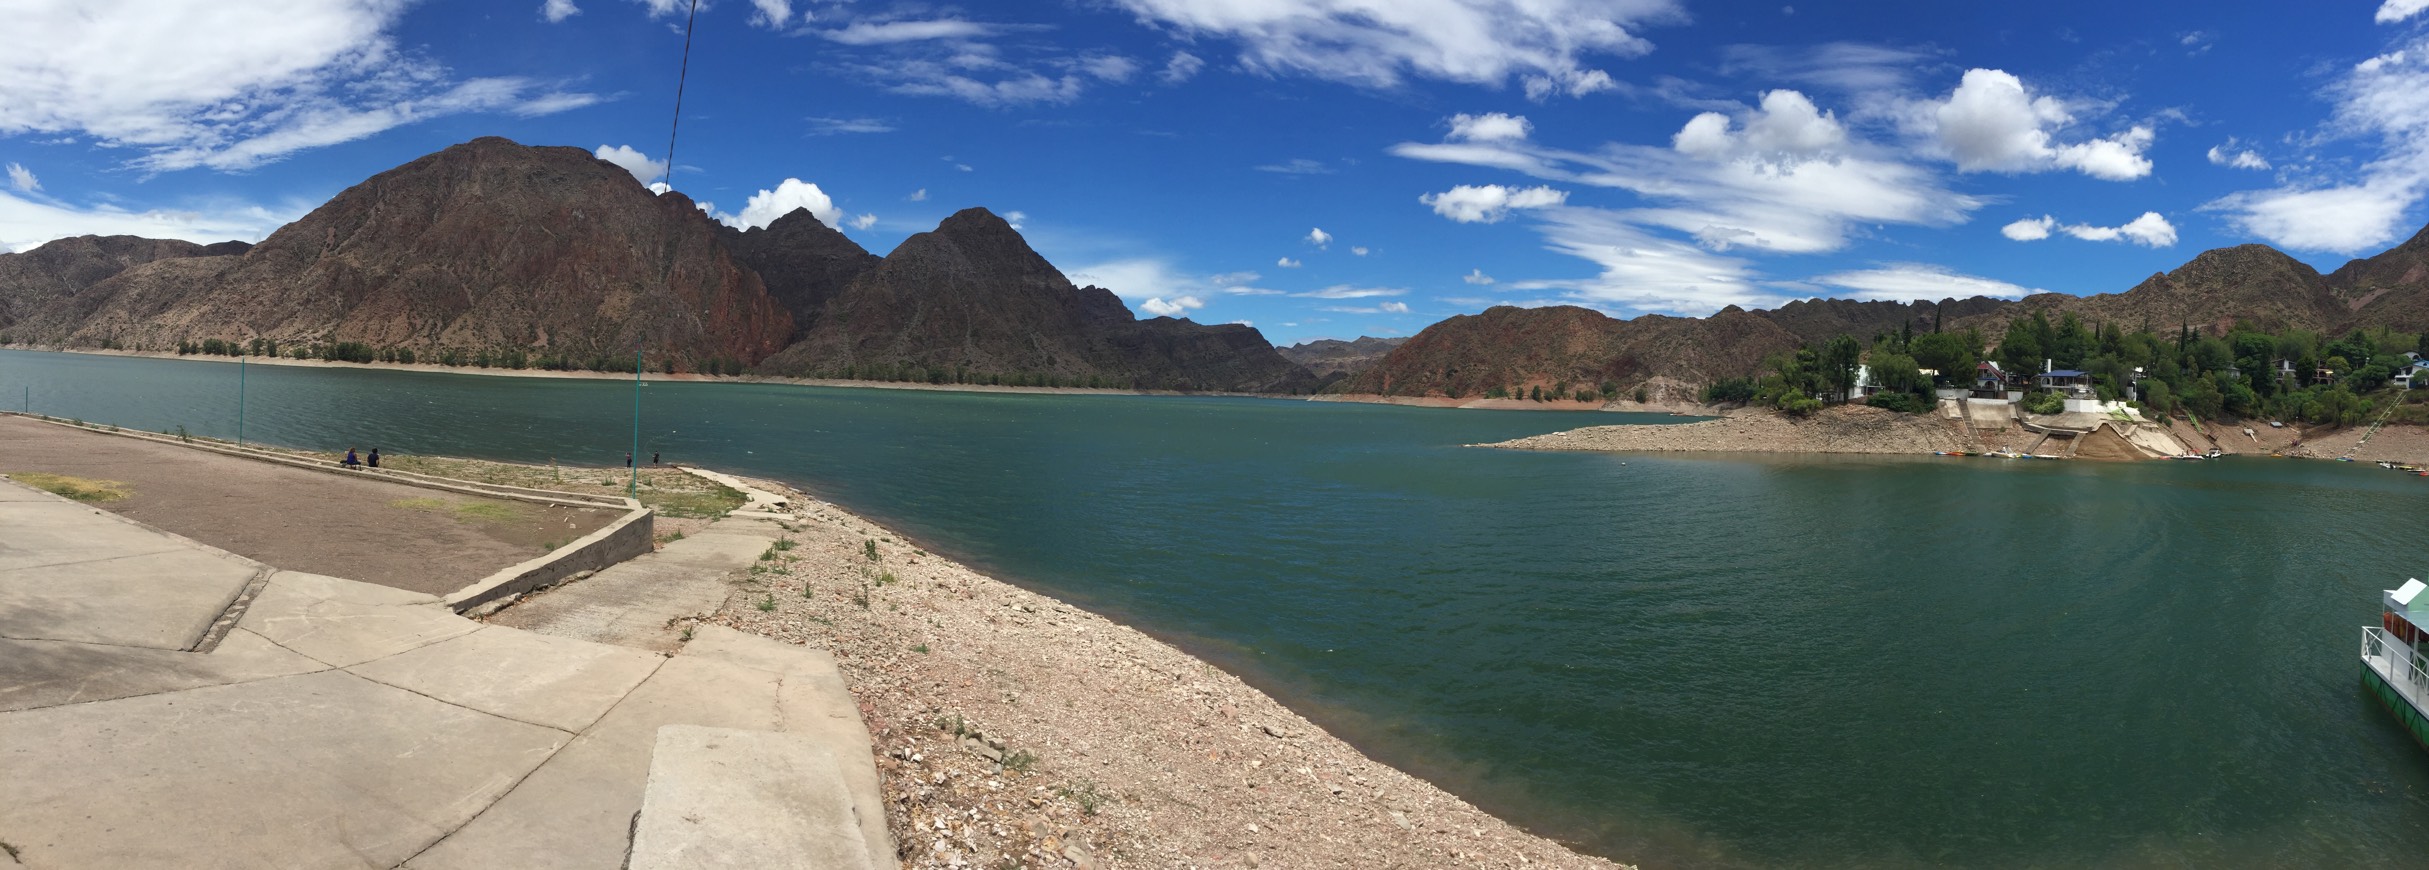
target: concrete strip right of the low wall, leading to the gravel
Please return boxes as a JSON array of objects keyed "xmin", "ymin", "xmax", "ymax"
[{"xmin": 491, "ymin": 515, "xmax": 787, "ymax": 651}]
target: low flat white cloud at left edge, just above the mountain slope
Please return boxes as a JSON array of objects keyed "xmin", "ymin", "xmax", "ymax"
[{"xmin": 0, "ymin": 192, "xmax": 318, "ymax": 253}]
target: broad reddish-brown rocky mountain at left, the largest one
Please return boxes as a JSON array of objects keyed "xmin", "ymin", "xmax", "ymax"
[{"xmin": 15, "ymin": 139, "xmax": 794, "ymax": 369}]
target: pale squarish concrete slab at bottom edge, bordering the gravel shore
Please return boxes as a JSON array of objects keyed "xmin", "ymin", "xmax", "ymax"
[{"xmin": 629, "ymin": 724, "xmax": 872, "ymax": 870}]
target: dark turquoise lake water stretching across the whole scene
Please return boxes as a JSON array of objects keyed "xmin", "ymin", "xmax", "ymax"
[{"xmin": 0, "ymin": 350, "xmax": 2429, "ymax": 868}]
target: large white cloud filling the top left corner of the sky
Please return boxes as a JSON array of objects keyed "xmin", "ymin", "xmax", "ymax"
[{"xmin": 0, "ymin": 0, "xmax": 598, "ymax": 173}]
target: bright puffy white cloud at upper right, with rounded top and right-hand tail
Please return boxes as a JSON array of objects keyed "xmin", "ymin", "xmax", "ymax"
[{"xmin": 1912, "ymin": 68, "xmax": 2157, "ymax": 182}]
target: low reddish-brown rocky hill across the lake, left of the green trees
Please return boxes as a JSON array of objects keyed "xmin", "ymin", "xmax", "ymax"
[{"xmin": 1336, "ymin": 306, "xmax": 1802, "ymax": 399}]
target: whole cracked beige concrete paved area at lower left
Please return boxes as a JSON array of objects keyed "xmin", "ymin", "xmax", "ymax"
[{"xmin": 0, "ymin": 459, "xmax": 896, "ymax": 870}]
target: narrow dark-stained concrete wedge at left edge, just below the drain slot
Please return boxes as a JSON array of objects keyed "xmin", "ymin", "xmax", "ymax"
[{"xmin": 0, "ymin": 629, "xmax": 328, "ymax": 712}]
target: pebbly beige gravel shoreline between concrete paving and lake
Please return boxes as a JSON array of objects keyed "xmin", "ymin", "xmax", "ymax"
[{"xmin": 709, "ymin": 481, "xmax": 1618, "ymax": 868}]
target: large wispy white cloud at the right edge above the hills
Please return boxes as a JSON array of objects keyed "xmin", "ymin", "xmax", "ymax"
[{"xmin": 2203, "ymin": 39, "xmax": 2429, "ymax": 253}]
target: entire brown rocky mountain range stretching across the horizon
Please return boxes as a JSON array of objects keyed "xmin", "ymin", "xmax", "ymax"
[{"xmin": 0, "ymin": 139, "xmax": 2429, "ymax": 399}]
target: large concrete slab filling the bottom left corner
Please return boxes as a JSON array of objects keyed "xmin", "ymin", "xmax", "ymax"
[{"xmin": 0, "ymin": 671, "xmax": 565, "ymax": 868}]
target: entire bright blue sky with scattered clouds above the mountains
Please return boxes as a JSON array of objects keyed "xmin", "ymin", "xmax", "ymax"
[{"xmin": 0, "ymin": 0, "xmax": 2429, "ymax": 343}]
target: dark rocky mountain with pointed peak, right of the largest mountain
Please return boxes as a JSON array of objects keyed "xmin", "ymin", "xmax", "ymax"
[{"xmin": 760, "ymin": 209, "xmax": 1314, "ymax": 391}]
